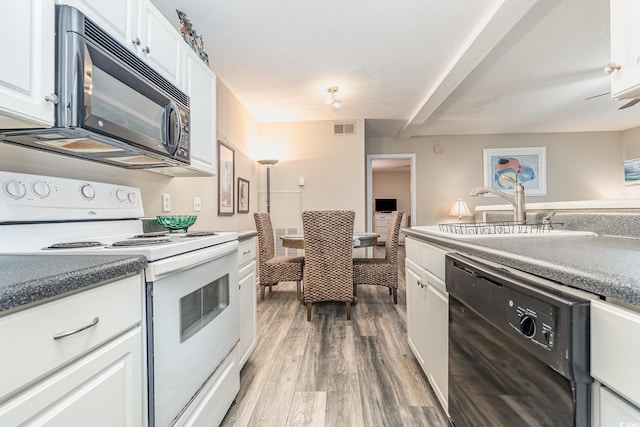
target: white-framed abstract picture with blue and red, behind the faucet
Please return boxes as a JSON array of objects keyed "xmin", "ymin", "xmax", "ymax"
[{"xmin": 484, "ymin": 147, "xmax": 547, "ymax": 197}]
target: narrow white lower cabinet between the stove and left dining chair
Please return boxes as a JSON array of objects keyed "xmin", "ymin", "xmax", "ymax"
[{"xmin": 237, "ymin": 237, "xmax": 257, "ymax": 368}]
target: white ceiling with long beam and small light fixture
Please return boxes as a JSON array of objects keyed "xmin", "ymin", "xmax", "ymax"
[{"xmin": 152, "ymin": 0, "xmax": 640, "ymax": 137}]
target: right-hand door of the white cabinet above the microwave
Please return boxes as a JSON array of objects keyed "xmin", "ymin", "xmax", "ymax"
[{"xmin": 138, "ymin": 0, "xmax": 186, "ymax": 90}]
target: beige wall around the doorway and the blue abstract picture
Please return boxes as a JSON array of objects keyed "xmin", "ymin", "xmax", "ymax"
[{"xmin": 366, "ymin": 132, "xmax": 630, "ymax": 225}]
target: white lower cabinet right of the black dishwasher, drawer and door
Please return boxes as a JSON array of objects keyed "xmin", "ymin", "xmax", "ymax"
[{"xmin": 591, "ymin": 301, "xmax": 640, "ymax": 427}]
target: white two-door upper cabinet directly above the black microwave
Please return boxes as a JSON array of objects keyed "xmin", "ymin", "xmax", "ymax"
[{"xmin": 58, "ymin": 0, "xmax": 186, "ymax": 90}]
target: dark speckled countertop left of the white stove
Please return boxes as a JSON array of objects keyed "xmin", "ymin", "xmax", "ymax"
[{"xmin": 0, "ymin": 255, "xmax": 147, "ymax": 316}]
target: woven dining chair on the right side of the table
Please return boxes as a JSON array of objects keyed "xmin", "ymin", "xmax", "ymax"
[{"xmin": 353, "ymin": 211, "xmax": 403, "ymax": 304}]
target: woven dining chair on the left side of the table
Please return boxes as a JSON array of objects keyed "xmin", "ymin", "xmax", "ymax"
[{"xmin": 253, "ymin": 212, "xmax": 304, "ymax": 300}]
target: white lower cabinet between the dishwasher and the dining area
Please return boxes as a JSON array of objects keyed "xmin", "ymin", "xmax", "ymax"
[{"xmin": 405, "ymin": 238, "xmax": 449, "ymax": 413}]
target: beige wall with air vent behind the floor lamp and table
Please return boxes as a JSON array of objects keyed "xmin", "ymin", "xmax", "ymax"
[{"xmin": 255, "ymin": 120, "xmax": 365, "ymax": 230}]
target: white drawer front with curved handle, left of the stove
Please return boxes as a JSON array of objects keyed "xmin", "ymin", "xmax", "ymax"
[{"xmin": 0, "ymin": 275, "xmax": 142, "ymax": 399}]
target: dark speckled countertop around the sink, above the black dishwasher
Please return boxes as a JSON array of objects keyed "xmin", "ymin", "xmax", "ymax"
[{"xmin": 403, "ymin": 228, "xmax": 640, "ymax": 308}]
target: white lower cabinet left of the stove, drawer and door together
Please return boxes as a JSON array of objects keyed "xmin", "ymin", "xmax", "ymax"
[{"xmin": 0, "ymin": 275, "xmax": 146, "ymax": 426}]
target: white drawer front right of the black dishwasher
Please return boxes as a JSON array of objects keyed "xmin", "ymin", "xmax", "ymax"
[{"xmin": 591, "ymin": 301, "xmax": 640, "ymax": 406}]
